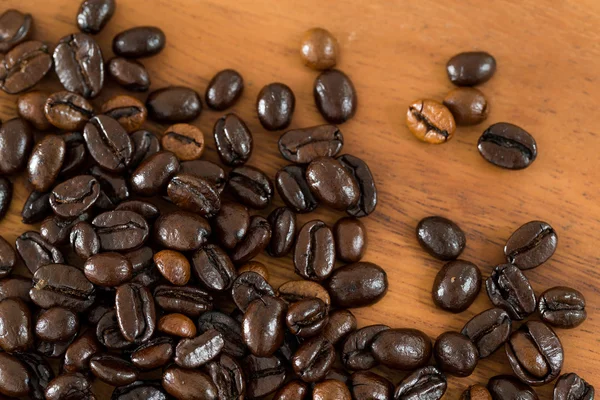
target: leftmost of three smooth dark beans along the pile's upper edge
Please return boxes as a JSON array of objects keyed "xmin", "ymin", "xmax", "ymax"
[{"xmin": 205, "ymin": 69, "xmax": 244, "ymax": 111}]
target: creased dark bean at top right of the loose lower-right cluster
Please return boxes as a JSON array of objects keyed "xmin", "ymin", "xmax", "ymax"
[{"xmin": 504, "ymin": 221, "xmax": 558, "ymax": 270}]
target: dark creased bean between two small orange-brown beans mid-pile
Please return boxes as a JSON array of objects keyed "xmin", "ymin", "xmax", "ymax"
[{"xmin": 192, "ymin": 244, "xmax": 236, "ymax": 292}]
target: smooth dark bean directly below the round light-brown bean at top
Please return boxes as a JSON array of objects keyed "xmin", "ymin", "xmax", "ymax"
[{"xmin": 313, "ymin": 69, "xmax": 358, "ymax": 124}]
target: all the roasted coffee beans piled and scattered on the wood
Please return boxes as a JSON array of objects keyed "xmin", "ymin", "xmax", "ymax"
[{"xmin": 0, "ymin": 0, "xmax": 594, "ymax": 400}]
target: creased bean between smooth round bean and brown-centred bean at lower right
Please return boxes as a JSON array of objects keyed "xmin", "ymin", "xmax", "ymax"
[{"xmin": 461, "ymin": 308, "xmax": 512, "ymax": 358}]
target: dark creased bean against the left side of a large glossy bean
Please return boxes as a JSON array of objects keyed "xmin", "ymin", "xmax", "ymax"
[{"xmin": 275, "ymin": 165, "xmax": 319, "ymax": 213}]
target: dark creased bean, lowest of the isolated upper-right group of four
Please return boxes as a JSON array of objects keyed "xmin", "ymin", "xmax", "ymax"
[{"xmin": 477, "ymin": 122, "xmax": 537, "ymax": 169}]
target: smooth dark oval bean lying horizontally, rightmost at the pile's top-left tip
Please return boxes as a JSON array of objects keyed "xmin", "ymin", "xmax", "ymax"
[{"xmin": 112, "ymin": 26, "xmax": 167, "ymax": 58}]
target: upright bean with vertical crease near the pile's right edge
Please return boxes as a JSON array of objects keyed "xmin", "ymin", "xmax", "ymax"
[{"xmin": 294, "ymin": 220, "xmax": 335, "ymax": 281}]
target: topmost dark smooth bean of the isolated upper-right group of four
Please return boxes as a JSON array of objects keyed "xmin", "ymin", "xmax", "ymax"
[{"xmin": 446, "ymin": 51, "xmax": 496, "ymax": 86}]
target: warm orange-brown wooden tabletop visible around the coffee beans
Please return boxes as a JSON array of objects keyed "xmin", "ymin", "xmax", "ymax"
[{"xmin": 0, "ymin": 0, "xmax": 600, "ymax": 399}]
